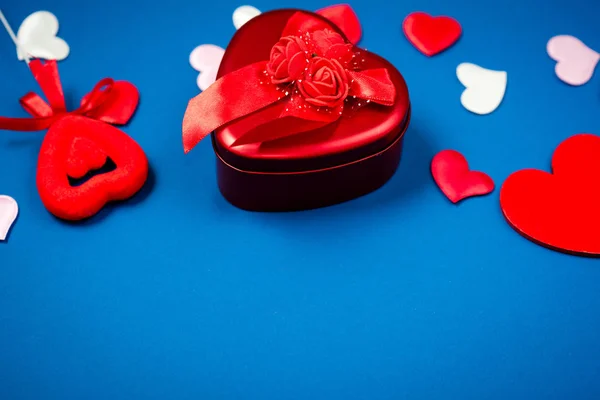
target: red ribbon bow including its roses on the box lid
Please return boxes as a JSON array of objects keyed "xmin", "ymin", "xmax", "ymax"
[{"xmin": 183, "ymin": 12, "xmax": 396, "ymax": 153}]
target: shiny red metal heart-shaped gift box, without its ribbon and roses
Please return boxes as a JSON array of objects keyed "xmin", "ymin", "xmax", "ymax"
[{"xmin": 211, "ymin": 9, "xmax": 410, "ymax": 211}]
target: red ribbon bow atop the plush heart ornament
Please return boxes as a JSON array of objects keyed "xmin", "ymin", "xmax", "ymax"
[{"xmin": 0, "ymin": 59, "xmax": 139, "ymax": 131}]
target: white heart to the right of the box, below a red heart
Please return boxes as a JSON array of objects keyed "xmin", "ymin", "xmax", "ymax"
[{"xmin": 456, "ymin": 63, "xmax": 508, "ymax": 115}]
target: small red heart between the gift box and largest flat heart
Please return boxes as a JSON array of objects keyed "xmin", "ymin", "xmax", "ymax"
[{"xmin": 431, "ymin": 150, "xmax": 494, "ymax": 203}]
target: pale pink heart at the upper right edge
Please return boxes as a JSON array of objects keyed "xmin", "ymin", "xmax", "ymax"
[{"xmin": 546, "ymin": 35, "xmax": 600, "ymax": 86}]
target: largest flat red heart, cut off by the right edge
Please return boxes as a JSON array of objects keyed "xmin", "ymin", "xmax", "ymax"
[{"xmin": 500, "ymin": 134, "xmax": 600, "ymax": 256}]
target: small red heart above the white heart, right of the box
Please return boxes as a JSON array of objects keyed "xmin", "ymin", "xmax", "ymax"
[{"xmin": 402, "ymin": 12, "xmax": 462, "ymax": 57}]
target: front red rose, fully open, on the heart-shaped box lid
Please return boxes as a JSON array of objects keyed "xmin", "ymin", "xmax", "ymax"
[{"xmin": 298, "ymin": 57, "xmax": 349, "ymax": 108}]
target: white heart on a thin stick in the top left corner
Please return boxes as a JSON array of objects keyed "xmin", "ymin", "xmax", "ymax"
[{"xmin": 17, "ymin": 11, "xmax": 69, "ymax": 60}]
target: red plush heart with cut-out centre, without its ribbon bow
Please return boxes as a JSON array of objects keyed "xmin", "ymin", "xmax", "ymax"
[{"xmin": 37, "ymin": 116, "xmax": 148, "ymax": 220}]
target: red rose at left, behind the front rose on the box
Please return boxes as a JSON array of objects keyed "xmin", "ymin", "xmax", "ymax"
[{"xmin": 267, "ymin": 36, "xmax": 308, "ymax": 84}]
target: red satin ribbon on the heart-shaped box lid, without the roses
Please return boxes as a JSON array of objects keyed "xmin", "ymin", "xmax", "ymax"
[{"xmin": 183, "ymin": 13, "xmax": 396, "ymax": 153}]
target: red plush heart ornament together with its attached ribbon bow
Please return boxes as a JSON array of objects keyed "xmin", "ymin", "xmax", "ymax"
[{"xmin": 0, "ymin": 60, "xmax": 148, "ymax": 220}]
